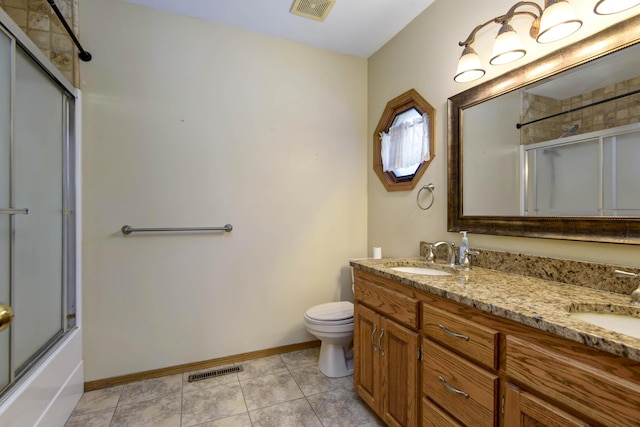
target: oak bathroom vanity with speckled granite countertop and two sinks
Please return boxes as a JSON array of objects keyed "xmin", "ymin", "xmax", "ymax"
[{"xmin": 351, "ymin": 247, "xmax": 640, "ymax": 427}]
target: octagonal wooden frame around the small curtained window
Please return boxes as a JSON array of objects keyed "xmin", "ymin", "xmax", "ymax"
[{"xmin": 373, "ymin": 89, "xmax": 436, "ymax": 191}]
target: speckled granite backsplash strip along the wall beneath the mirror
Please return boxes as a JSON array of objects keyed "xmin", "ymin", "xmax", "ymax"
[{"xmin": 420, "ymin": 242, "xmax": 640, "ymax": 295}]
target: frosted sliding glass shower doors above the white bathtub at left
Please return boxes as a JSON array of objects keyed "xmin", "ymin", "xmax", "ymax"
[{"xmin": 0, "ymin": 25, "xmax": 75, "ymax": 402}]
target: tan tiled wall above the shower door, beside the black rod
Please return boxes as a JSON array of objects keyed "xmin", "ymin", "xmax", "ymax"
[{"xmin": 0, "ymin": 0, "xmax": 79, "ymax": 87}]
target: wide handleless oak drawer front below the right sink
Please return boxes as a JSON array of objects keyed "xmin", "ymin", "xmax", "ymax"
[{"xmin": 505, "ymin": 335, "xmax": 640, "ymax": 427}]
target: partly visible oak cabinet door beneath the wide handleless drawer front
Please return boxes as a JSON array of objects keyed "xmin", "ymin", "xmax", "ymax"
[{"xmin": 504, "ymin": 384, "xmax": 589, "ymax": 427}]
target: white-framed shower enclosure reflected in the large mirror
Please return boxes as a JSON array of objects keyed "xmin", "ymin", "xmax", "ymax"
[{"xmin": 520, "ymin": 123, "xmax": 640, "ymax": 216}]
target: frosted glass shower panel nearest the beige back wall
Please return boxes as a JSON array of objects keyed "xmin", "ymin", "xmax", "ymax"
[{"xmin": 12, "ymin": 50, "xmax": 64, "ymax": 375}]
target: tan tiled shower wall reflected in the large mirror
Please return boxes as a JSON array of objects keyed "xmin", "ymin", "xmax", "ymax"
[{"xmin": 520, "ymin": 77, "xmax": 640, "ymax": 145}]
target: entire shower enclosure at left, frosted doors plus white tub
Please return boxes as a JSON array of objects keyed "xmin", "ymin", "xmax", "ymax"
[{"xmin": 0, "ymin": 8, "xmax": 82, "ymax": 426}]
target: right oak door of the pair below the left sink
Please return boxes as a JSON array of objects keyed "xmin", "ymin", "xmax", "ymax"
[{"xmin": 378, "ymin": 318, "xmax": 420, "ymax": 427}]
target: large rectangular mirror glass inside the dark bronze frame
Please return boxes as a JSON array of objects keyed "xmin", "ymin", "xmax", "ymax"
[{"xmin": 463, "ymin": 45, "xmax": 640, "ymax": 216}]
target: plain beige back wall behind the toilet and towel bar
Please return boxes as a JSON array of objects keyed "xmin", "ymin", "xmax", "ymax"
[{"xmin": 80, "ymin": 0, "xmax": 368, "ymax": 381}]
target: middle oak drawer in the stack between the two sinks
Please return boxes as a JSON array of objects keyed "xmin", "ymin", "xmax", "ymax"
[{"xmin": 422, "ymin": 339, "xmax": 498, "ymax": 427}]
